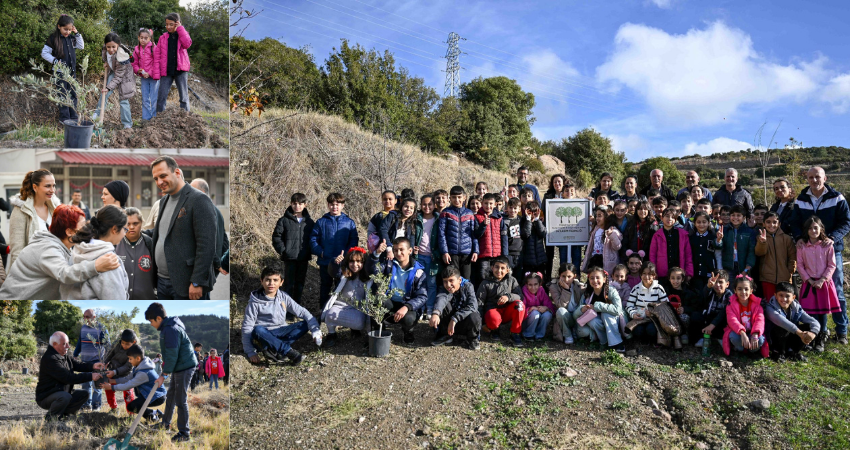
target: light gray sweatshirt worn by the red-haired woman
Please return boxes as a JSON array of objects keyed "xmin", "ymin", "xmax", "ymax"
[{"xmin": 0, "ymin": 231, "xmax": 97, "ymax": 300}]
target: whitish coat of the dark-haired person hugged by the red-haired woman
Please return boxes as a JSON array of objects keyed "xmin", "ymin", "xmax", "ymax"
[{"xmin": 59, "ymin": 239, "xmax": 130, "ymax": 300}]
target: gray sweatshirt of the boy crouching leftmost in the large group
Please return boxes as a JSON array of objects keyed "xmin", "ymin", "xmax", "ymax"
[{"xmin": 242, "ymin": 289, "xmax": 320, "ymax": 357}]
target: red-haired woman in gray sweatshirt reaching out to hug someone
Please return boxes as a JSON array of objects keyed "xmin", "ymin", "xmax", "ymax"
[{"xmin": 0, "ymin": 205, "xmax": 120, "ymax": 300}]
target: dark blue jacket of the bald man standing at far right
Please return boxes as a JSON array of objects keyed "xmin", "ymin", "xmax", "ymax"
[{"xmin": 791, "ymin": 184, "xmax": 850, "ymax": 254}]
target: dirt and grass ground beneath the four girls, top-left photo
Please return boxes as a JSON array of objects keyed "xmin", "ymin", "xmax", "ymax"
[{"xmin": 0, "ymin": 74, "xmax": 229, "ymax": 148}]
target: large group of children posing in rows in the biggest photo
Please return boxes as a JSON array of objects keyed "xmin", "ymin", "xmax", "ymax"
[{"xmin": 256, "ymin": 175, "xmax": 840, "ymax": 361}]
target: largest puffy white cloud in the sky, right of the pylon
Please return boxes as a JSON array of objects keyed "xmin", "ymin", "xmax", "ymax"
[{"xmin": 596, "ymin": 22, "xmax": 823, "ymax": 127}]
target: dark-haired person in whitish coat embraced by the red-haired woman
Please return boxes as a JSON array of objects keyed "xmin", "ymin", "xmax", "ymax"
[{"xmin": 59, "ymin": 205, "xmax": 130, "ymax": 300}]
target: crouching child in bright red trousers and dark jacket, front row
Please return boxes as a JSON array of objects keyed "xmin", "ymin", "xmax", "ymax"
[{"xmin": 477, "ymin": 256, "xmax": 525, "ymax": 347}]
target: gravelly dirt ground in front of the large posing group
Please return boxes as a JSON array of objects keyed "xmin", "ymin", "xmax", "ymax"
[{"xmin": 231, "ymin": 262, "xmax": 850, "ymax": 450}]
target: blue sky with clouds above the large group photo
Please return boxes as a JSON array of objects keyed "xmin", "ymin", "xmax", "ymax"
[{"xmin": 237, "ymin": 0, "xmax": 850, "ymax": 161}]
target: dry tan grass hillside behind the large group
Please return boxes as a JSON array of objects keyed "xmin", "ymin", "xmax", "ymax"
[{"xmin": 230, "ymin": 110, "xmax": 548, "ymax": 296}]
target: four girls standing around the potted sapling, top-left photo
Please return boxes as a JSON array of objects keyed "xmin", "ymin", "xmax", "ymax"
[{"xmin": 41, "ymin": 13, "xmax": 192, "ymax": 128}]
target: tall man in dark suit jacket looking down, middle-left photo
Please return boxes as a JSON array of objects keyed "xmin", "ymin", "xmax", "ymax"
[{"xmin": 151, "ymin": 156, "xmax": 217, "ymax": 300}]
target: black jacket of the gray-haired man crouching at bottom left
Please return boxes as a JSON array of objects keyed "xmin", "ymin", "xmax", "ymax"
[{"xmin": 35, "ymin": 346, "xmax": 94, "ymax": 402}]
